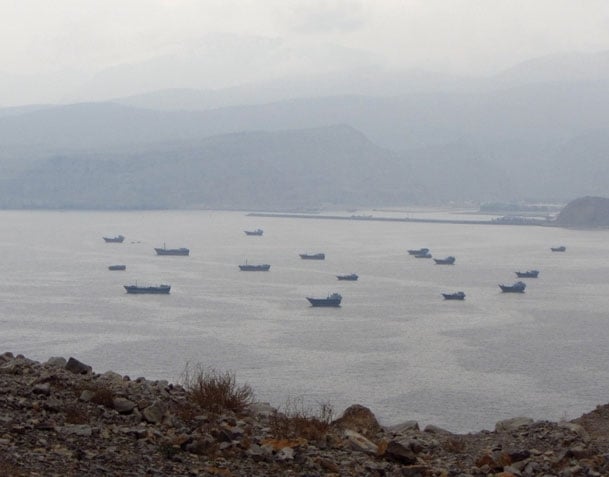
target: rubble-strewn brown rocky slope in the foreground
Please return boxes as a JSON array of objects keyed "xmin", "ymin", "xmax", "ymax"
[{"xmin": 0, "ymin": 353, "xmax": 609, "ymax": 477}]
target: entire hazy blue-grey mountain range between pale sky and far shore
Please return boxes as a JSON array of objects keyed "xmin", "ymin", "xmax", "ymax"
[{"xmin": 0, "ymin": 48, "xmax": 609, "ymax": 208}]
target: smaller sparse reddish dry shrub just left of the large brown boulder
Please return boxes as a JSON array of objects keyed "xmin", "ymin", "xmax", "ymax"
[{"xmin": 270, "ymin": 399, "xmax": 334, "ymax": 441}]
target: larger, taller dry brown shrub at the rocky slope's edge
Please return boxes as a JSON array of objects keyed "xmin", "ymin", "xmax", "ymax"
[{"xmin": 181, "ymin": 364, "xmax": 254, "ymax": 414}]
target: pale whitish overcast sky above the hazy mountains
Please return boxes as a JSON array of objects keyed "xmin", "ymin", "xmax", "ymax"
[{"xmin": 0, "ymin": 0, "xmax": 609, "ymax": 104}]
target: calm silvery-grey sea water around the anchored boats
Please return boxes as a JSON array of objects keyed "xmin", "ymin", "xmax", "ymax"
[{"xmin": 0, "ymin": 211, "xmax": 609, "ymax": 432}]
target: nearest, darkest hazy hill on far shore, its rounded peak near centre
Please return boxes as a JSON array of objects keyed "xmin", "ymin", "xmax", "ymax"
[{"xmin": 0, "ymin": 126, "xmax": 421, "ymax": 210}]
